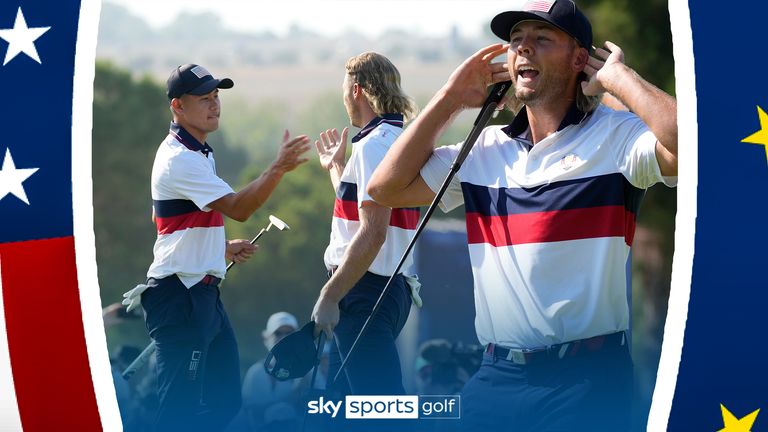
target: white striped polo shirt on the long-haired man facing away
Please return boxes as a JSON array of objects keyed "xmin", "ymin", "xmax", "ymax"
[{"xmin": 324, "ymin": 114, "xmax": 419, "ymax": 276}]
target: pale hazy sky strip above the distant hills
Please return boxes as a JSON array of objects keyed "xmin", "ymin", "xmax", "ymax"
[{"xmin": 102, "ymin": 0, "xmax": 524, "ymax": 36}]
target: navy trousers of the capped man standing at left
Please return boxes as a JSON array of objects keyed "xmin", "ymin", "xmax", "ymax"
[{"xmin": 141, "ymin": 275, "xmax": 241, "ymax": 432}]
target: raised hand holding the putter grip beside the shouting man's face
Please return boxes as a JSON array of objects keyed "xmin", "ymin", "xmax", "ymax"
[{"xmin": 443, "ymin": 44, "xmax": 510, "ymax": 109}]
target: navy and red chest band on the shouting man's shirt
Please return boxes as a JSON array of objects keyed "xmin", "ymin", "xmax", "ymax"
[{"xmin": 461, "ymin": 173, "xmax": 644, "ymax": 246}]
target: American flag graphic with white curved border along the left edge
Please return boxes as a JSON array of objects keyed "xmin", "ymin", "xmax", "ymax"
[{"xmin": 0, "ymin": 0, "xmax": 122, "ymax": 432}]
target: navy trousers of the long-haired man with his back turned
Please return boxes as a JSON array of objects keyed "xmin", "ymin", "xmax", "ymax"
[{"xmin": 328, "ymin": 272, "xmax": 411, "ymax": 395}]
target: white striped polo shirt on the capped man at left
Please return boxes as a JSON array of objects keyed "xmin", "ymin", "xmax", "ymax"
[{"xmin": 147, "ymin": 123, "xmax": 234, "ymax": 288}]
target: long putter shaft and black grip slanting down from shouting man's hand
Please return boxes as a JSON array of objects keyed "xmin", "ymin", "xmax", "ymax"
[{"xmin": 332, "ymin": 81, "xmax": 512, "ymax": 383}]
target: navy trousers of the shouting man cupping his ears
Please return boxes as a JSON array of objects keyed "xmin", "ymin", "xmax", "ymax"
[{"xmin": 461, "ymin": 344, "xmax": 633, "ymax": 432}]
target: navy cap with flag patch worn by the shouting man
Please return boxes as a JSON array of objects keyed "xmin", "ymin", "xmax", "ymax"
[{"xmin": 491, "ymin": 0, "xmax": 592, "ymax": 52}]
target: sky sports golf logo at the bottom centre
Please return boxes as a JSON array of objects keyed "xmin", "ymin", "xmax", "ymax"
[{"xmin": 307, "ymin": 395, "xmax": 461, "ymax": 419}]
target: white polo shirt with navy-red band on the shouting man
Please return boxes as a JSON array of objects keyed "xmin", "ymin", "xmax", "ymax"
[{"xmin": 421, "ymin": 105, "xmax": 676, "ymax": 349}]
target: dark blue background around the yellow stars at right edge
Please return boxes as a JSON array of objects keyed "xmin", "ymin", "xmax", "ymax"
[{"xmin": 665, "ymin": 1, "xmax": 768, "ymax": 431}]
